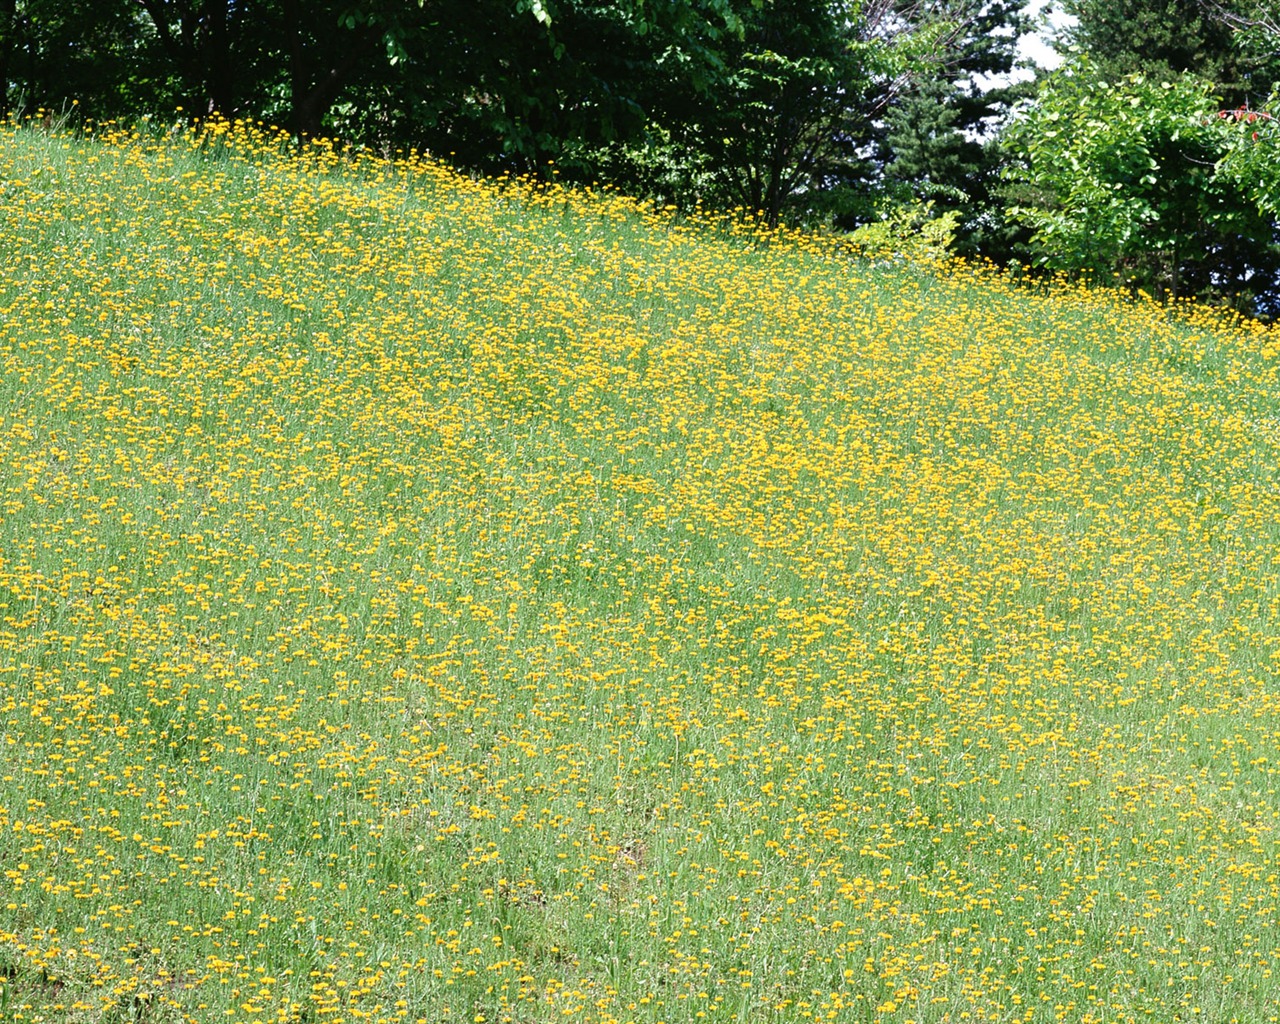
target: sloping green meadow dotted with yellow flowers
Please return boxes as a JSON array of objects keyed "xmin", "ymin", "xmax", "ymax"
[{"xmin": 0, "ymin": 128, "xmax": 1280, "ymax": 1024}]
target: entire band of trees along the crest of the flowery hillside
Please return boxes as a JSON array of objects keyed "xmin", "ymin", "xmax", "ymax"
[{"xmin": 0, "ymin": 0, "xmax": 1280, "ymax": 314}]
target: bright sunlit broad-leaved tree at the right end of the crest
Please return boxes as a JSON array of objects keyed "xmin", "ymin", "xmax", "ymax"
[{"xmin": 1005, "ymin": 61, "xmax": 1277, "ymax": 302}]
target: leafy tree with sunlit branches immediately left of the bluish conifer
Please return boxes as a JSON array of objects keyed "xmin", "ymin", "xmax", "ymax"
[{"xmin": 609, "ymin": 0, "xmax": 988, "ymax": 224}]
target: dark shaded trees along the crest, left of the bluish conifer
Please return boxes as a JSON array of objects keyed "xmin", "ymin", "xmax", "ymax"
[{"xmin": 0, "ymin": 0, "xmax": 1023, "ymax": 223}]
